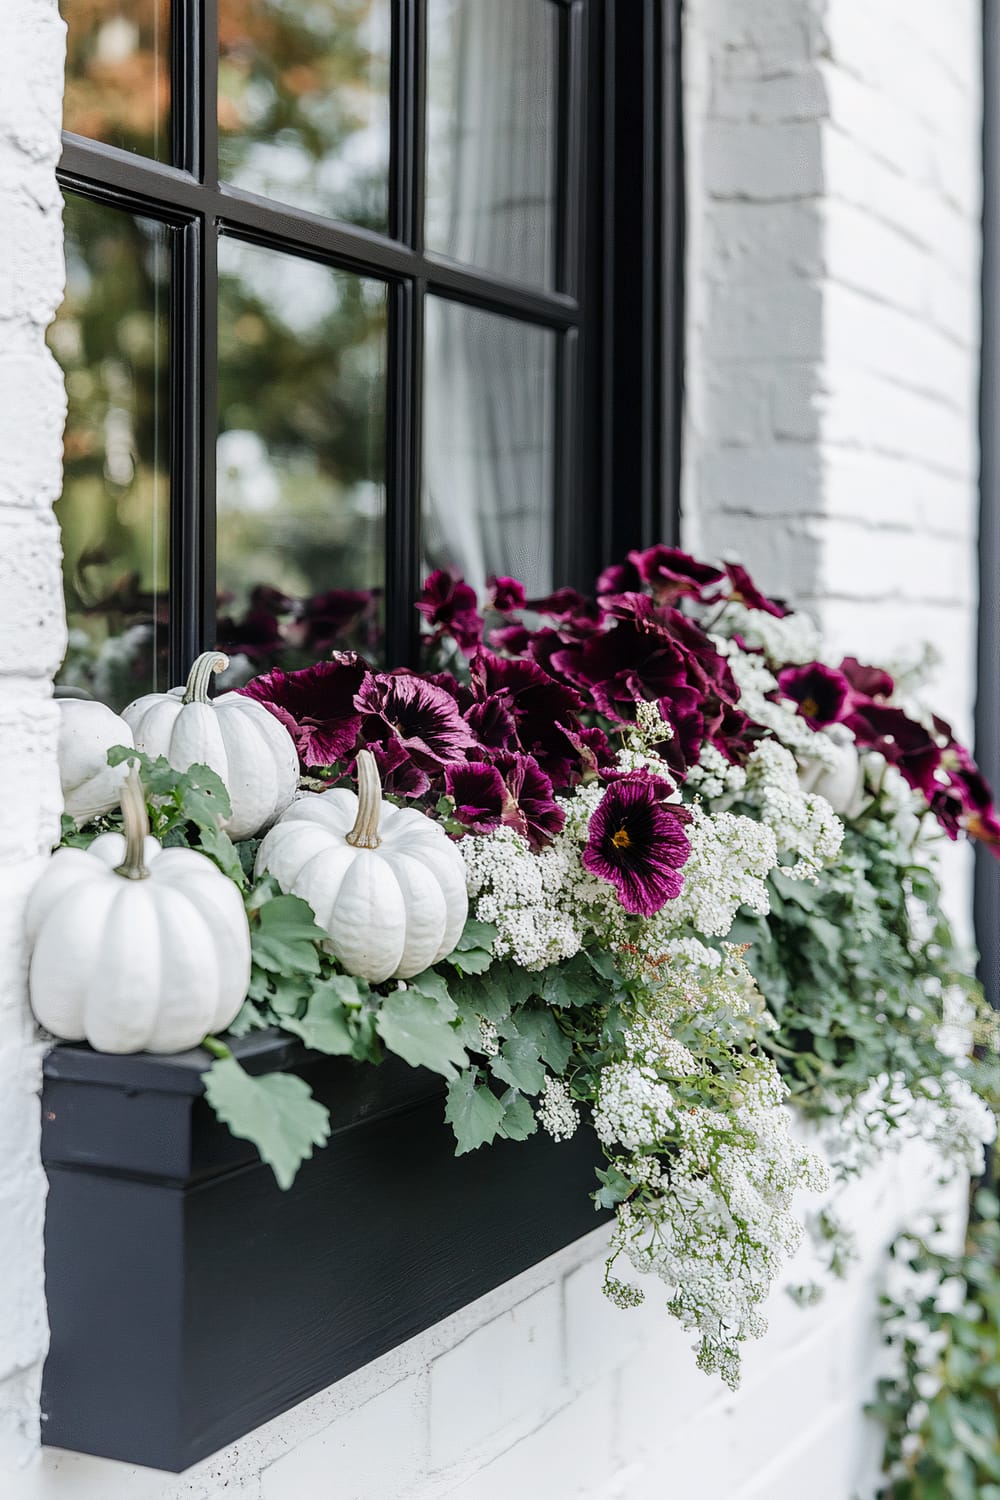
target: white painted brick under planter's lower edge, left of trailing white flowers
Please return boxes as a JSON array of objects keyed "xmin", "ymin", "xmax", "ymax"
[{"xmin": 430, "ymin": 1286, "xmax": 562, "ymax": 1469}]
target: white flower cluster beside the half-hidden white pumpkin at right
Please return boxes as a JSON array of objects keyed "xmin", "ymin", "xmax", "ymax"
[{"xmin": 745, "ymin": 740, "xmax": 844, "ymax": 881}]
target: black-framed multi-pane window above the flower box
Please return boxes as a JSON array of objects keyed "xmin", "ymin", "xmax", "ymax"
[{"xmin": 51, "ymin": 0, "xmax": 679, "ymax": 705}]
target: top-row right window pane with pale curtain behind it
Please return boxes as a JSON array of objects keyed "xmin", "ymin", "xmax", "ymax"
[{"xmin": 424, "ymin": 0, "xmax": 559, "ymax": 287}]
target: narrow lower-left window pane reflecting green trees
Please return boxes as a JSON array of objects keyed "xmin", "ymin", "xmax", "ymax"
[{"xmin": 48, "ymin": 194, "xmax": 171, "ymax": 708}]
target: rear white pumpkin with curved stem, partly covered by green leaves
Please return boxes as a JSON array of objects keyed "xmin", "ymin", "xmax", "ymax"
[{"xmin": 121, "ymin": 651, "xmax": 298, "ymax": 839}]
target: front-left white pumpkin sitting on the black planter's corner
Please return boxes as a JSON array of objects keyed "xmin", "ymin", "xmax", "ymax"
[{"xmin": 25, "ymin": 771, "xmax": 250, "ymax": 1053}]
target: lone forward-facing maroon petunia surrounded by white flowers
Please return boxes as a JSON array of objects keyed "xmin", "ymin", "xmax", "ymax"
[{"xmin": 582, "ymin": 771, "xmax": 691, "ymax": 917}]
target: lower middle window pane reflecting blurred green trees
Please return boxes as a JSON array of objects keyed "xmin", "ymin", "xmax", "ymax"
[{"xmin": 217, "ymin": 239, "xmax": 387, "ymax": 675}]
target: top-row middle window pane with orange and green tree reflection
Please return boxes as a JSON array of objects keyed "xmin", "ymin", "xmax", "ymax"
[{"xmin": 219, "ymin": 0, "xmax": 391, "ymax": 230}]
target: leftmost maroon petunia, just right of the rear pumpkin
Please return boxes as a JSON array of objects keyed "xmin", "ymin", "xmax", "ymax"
[{"xmin": 237, "ymin": 651, "xmax": 367, "ymax": 767}]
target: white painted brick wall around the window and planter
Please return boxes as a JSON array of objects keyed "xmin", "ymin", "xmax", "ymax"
[{"xmin": 0, "ymin": 0, "xmax": 979, "ymax": 1500}]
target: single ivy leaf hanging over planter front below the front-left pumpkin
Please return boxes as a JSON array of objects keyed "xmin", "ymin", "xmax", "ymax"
[{"xmin": 202, "ymin": 1058, "xmax": 330, "ymax": 1188}]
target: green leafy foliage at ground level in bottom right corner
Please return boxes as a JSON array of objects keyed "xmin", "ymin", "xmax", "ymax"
[{"xmin": 871, "ymin": 1191, "xmax": 1000, "ymax": 1500}]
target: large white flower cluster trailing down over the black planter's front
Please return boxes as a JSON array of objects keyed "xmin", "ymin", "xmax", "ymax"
[{"xmin": 598, "ymin": 1058, "xmax": 828, "ymax": 1388}]
